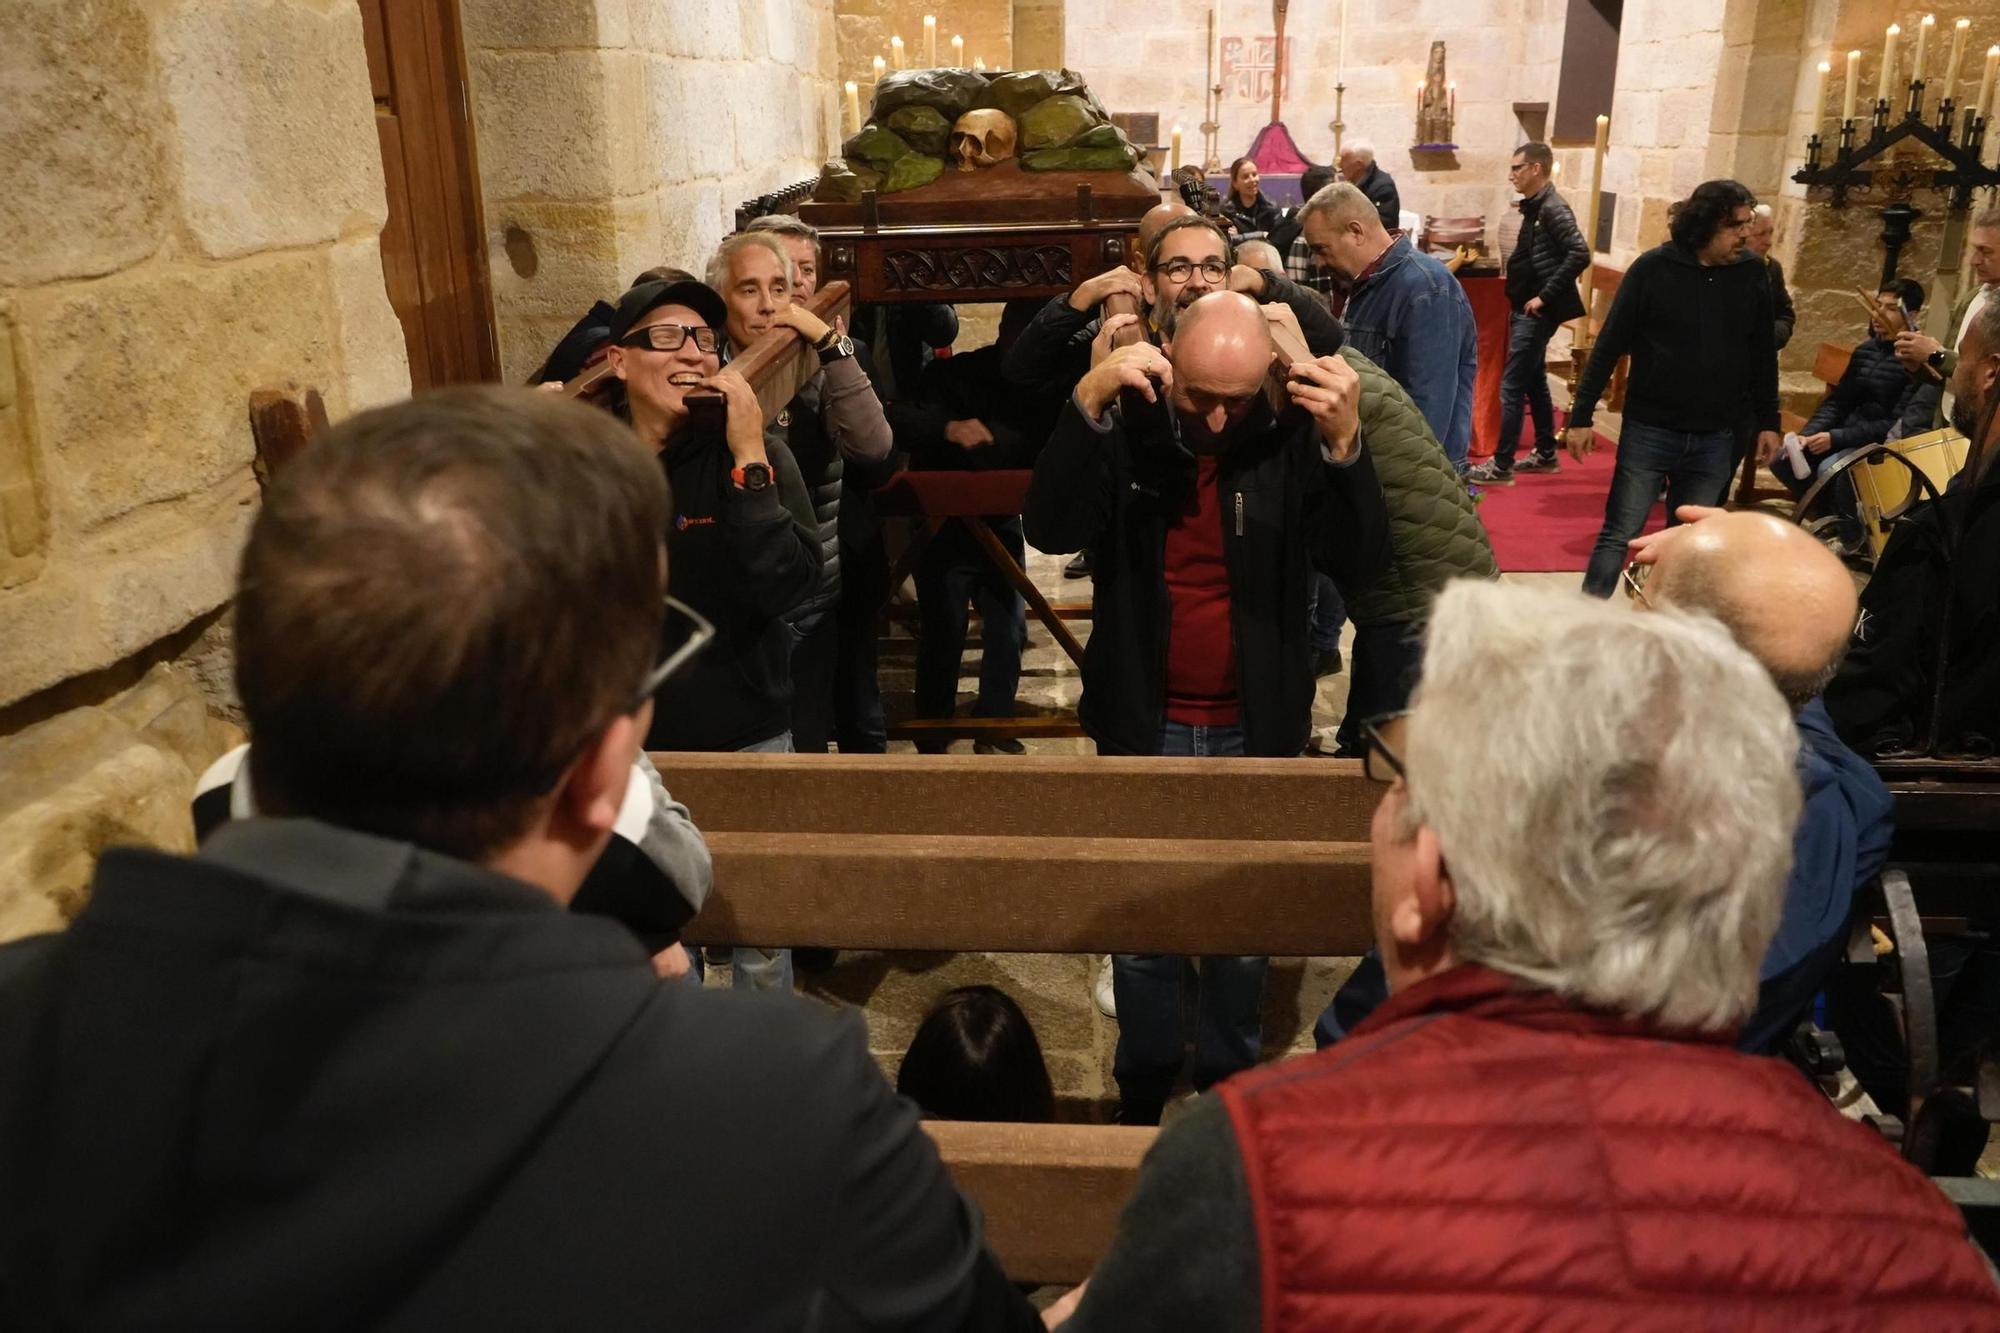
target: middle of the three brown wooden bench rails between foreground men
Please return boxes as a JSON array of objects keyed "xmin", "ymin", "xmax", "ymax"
[{"xmin": 686, "ymin": 832, "xmax": 1374, "ymax": 957}]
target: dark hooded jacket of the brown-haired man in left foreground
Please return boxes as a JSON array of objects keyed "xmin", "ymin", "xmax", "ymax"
[{"xmin": 0, "ymin": 819, "xmax": 1040, "ymax": 1333}]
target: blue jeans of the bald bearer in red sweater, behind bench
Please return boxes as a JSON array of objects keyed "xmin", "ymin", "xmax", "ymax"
[{"xmin": 1112, "ymin": 723, "xmax": 1270, "ymax": 1125}]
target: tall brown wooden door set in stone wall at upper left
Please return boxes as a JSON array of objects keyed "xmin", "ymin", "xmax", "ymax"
[{"xmin": 358, "ymin": 0, "xmax": 500, "ymax": 390}]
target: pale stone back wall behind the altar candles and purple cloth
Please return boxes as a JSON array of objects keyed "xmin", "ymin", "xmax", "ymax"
[{"xmin": 1064, "ymin": 0, "xmax": 1590, "ymax": 252}]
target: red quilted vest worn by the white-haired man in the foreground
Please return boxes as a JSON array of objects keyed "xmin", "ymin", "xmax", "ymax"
[{"xmin": 1220, "ymin": 967, "xmax": 2000, "ymax": 1333}]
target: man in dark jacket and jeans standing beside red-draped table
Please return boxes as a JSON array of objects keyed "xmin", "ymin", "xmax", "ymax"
[{"xmin": 1470, "ymin": 142, "xmax": 1590, "ymax": 486}]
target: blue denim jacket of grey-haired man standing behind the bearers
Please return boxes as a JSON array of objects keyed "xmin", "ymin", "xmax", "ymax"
[{"xmin": 1342, "ymin": 236, "xmax": 1480, "ymax": 464}]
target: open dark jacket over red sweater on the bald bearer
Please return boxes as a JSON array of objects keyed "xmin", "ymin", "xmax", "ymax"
[{"xmin": 1022, "ymin": 396, "xmax": 1390, "ymax": 757}]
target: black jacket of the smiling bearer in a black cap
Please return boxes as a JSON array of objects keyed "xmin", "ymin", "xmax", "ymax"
[{"xmin": 646, "ymin": 420, "xmax": 820, "ymax": 751}]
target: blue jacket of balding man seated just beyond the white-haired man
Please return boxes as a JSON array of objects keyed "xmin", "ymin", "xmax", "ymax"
[{"xmin": 1736, "ymin": 699, "xmax": 1896, "ymax": 1051}]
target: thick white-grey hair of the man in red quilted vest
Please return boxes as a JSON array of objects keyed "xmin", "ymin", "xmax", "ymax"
[{"xmin": 1404, "ymin": 578, "xmax": 1800, "ymax": 1029}]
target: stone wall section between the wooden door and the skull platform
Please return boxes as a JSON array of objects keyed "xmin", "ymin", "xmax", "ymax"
[{"xmin": 460, "ymin": 0, "xmax": 840, "ymax": 380}]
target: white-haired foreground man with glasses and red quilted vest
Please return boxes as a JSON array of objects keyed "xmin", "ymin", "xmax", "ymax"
[{"xmin": 1066, "ymin": 580, "xmax": 2000, "ymax": 1333}]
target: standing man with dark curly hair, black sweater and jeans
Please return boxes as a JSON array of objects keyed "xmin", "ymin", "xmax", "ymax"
[{"xmin": 1564, "ymin": 180, "xmax": 1778, "ymax": 596}]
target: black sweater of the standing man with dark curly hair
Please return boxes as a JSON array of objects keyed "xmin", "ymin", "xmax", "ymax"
[{"xmin": 1570, "ymin": 242, "xmax": 1778, "ymax": 430}]
